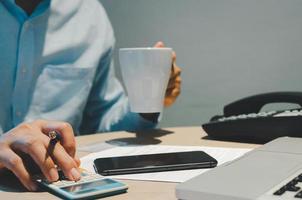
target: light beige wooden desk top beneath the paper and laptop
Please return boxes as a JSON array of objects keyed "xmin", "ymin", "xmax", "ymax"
[{"xmin": 0, "ymin": 127, "xmax": 259, "ymax": 200}]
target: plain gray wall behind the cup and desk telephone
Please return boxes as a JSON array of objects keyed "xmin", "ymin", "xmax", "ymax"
[{"xmin": 101, "ymin": 0, "xmax": 302, "ymax": 127}]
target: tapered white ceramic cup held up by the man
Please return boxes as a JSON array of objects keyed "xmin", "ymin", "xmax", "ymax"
[{"xmin": 119, "ymin": 47, "xmax": 173, "ymax": 113}]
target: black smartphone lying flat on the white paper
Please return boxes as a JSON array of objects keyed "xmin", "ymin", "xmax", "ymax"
[{"xmin": 94, "ymin": 151, "xmax": 217, "ymax": 176}]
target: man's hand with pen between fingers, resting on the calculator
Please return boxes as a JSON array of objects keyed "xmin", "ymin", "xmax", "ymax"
[{"xmin": 0, "ymin": 120, "xmax": 81, "ymax": 191}]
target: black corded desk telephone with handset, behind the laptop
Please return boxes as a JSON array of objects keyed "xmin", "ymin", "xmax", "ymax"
[{"xmin": 202, "ymin": 92, "xmax": 302, "ymax": 143}]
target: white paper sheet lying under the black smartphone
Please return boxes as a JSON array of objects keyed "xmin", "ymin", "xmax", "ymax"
[{"xmin": 81, "ymin": 145, "xmax": 251, "ymax": 182}]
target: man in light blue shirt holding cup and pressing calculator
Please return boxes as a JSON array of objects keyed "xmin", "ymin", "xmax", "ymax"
[{"xmin": 0, "ymin": 0, "xmax": 180, "ymax": 190}]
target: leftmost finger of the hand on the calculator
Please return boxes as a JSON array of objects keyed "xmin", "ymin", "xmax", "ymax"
[{"xmin": 0, "ymin": 149, "xmax": 37, "ymax": 191}]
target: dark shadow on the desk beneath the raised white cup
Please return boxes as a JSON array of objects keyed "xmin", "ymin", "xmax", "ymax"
[{"xmin": 106, "ymin": 129, "xmax": 174, "ymax": 146}]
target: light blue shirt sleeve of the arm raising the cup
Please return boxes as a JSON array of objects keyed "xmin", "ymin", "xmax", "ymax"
[{"xmin": 80, "ymin": 47, "xmax": 157, "ymax": 134}]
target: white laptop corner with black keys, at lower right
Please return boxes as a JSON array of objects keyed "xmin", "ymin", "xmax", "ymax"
[{"xmin": 176, "ymin": 137, "xmax": 302, "ymax": 200}]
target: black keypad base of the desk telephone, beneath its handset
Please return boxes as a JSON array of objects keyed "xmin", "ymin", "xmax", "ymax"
[{"xmin": 202, "ymin": 108, "xmax": 302, "ymax": 143}]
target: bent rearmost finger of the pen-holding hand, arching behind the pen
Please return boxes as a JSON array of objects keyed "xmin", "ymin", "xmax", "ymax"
[{"xmin": 37, "ymin": 120, "xmax": 76, "ymax": 157}]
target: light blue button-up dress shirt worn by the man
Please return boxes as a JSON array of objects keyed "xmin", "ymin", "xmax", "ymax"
[{"xmin": 0, "ymin": 0, "xmax": 156, "ymax": 134}]
